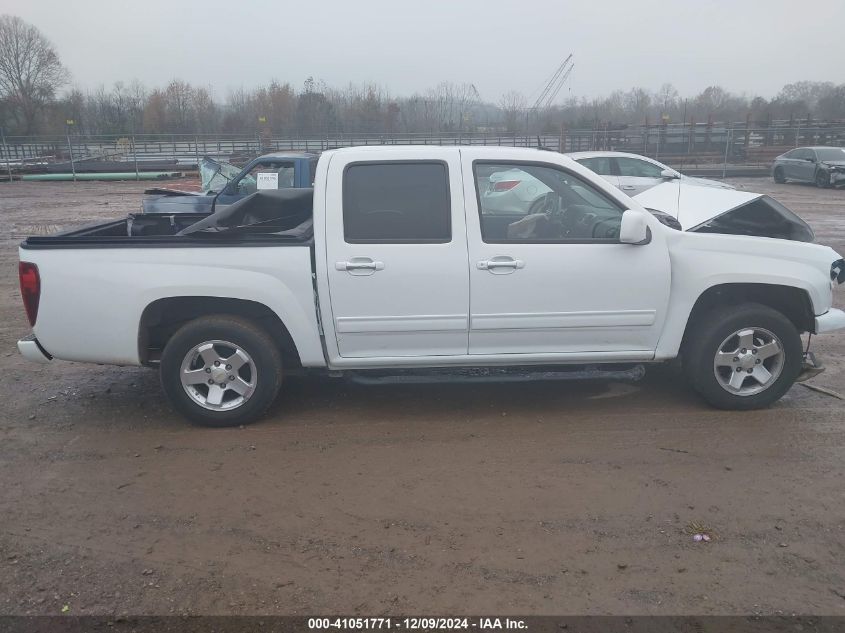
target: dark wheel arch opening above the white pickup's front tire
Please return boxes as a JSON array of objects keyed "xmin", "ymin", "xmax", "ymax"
[{"xmin": 684, "ymin": 284, "xmax": 815, "ymax": 348}]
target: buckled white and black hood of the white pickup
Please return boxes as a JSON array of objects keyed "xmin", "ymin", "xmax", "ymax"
[{"xmin": 634, "ymin": 181, "xmax": 815, "ymax": 242}]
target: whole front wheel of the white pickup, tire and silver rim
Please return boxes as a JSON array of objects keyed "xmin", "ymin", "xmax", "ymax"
[{"xmin": 683, "ymin": 303, "xmax": 803, "ymax": 409}]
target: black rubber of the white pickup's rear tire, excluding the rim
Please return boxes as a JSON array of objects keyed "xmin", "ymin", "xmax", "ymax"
[{"xmin": 160, "ymin": 315, "xmax": 282, "ymax": 427}]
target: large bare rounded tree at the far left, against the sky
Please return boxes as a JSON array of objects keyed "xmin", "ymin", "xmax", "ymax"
[{"xmin": 0, "ymin": 15, "xmax": 68, "ymax": 134}]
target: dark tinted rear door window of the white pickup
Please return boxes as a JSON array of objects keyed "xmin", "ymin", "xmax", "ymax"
[{"xmin": 343, "ymin": 161, "xmax": 452, "ymax": 244}]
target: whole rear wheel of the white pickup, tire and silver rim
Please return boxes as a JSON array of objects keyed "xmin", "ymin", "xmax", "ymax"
[{"xmin": 160, "ymin": 315, "xmax": 282, "ymax": 427}]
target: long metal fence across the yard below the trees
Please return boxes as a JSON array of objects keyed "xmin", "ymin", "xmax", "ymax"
[{"xmin": 0, "ymin": 124, "xmax": 845, "ymax": 178}]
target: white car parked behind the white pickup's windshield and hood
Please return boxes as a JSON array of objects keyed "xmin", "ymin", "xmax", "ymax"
[{"xmin": 567, "ymin": 152, "xmax": 734, "ymax": 196}]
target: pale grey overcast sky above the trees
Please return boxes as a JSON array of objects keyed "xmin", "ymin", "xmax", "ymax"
[{"xmin": 0, "ymin": 0, "xmax": 845, "ymax": 101}]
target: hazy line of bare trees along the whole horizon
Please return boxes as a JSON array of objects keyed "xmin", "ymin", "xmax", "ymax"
[{"xmin": 0, "ymin": 15, "xmax": 845, "ymax": 136}]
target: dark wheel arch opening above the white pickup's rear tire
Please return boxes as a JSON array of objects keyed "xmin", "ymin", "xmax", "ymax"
[{"xmin": 138, "ymin": 297, "xmax": 302, "ymax": 368}]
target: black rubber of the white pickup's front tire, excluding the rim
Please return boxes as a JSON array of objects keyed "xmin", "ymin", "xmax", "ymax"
[{"xmin": 683, "ymin": 303, "xmax": 803, "ymax": 410}]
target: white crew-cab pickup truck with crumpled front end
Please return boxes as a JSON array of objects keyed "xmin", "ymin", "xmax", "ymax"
[{"xmin": 18, "ymin": 147, "xmax": 845, "ymax": 426}]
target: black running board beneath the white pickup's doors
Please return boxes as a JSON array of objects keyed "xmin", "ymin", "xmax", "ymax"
[{"xmin": 343, "ymin": 365, "xmax": 645, "ymax": 385}]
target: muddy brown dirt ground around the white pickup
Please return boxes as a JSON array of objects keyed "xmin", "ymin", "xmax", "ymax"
[{"xmin": 0, "ymin": 179, "xmax": 845, "ymax": 615}]
